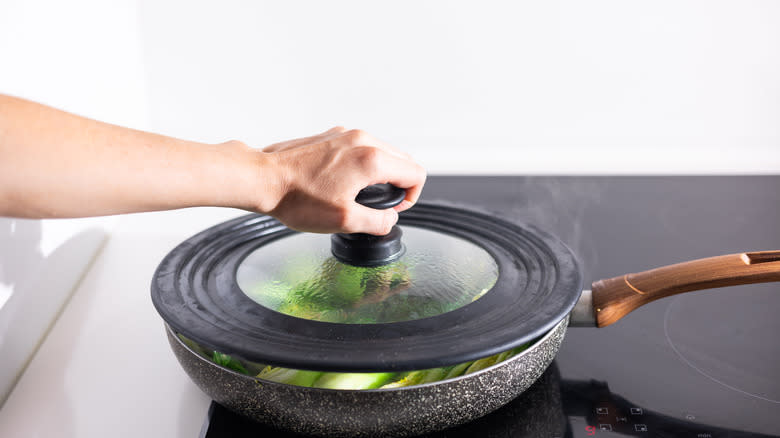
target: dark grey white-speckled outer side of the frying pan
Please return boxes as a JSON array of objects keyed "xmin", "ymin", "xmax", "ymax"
[{"xmin": 166, "ymin": 317, "xmax": 569, "ymax": 437}]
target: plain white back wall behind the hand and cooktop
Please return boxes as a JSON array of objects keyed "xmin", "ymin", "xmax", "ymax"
[{"xmin": 139, "ymin": 0, "xmax": 780, "ymax": 174}]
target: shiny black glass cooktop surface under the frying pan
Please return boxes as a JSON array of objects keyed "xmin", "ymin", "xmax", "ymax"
[{"xmin": 201, "ymin": 176, "xmax": 780, "ymax": 438}]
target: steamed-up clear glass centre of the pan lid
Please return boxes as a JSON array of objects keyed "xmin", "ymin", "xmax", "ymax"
[{"xmin": 236, "ymin": 225, "xmax": 498, "ymax": 324}]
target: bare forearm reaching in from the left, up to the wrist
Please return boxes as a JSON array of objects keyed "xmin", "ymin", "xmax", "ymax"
[{"xmin": 0, "ymin": 95, "xmax": 278, "ymax": 218}]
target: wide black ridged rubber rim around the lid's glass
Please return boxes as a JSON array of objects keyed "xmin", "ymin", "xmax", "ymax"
[{"xmin": 151, "ymin": 203, "xmax": 582, "ymax": 372}]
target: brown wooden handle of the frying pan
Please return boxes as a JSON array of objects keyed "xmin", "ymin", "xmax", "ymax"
[{"xmin": 591, "ymin": 251, "xmax": 780, "ymax": 327}]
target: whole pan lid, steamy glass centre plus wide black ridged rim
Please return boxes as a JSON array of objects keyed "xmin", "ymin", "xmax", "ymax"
[{"xmin": 151, "ymin": 202, "xmax": 582, "ymax": 372}]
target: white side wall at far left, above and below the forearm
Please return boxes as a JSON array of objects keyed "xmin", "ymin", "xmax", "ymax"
[{"xmin": 0, "ymin": 0, "xmax": 148, "ymax": 404}]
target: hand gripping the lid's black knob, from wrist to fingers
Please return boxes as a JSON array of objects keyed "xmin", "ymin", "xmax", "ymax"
[{"xmin": 263, "ymin": 127, "xmax": 426, "ymax": 235}]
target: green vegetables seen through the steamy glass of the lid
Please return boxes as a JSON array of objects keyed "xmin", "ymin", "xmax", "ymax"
[{"xmin": 245, "ymin": 257, "xmax": 487, "ymax": 324}]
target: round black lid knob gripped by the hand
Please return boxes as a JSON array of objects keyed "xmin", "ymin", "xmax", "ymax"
[{"xmin": 330, "ymin": 184, "xmax": 406, "ymax": 266}]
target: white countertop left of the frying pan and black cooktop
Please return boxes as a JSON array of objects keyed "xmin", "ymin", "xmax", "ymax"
[{"xmin": 0, "ymin": 208, "xmax": 245, "ymax": 438}]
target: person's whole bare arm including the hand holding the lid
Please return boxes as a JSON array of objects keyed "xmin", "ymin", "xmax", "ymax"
[{"xmin": 0, "ymin": 95, "xmax": 425, "ymax": 234}]
